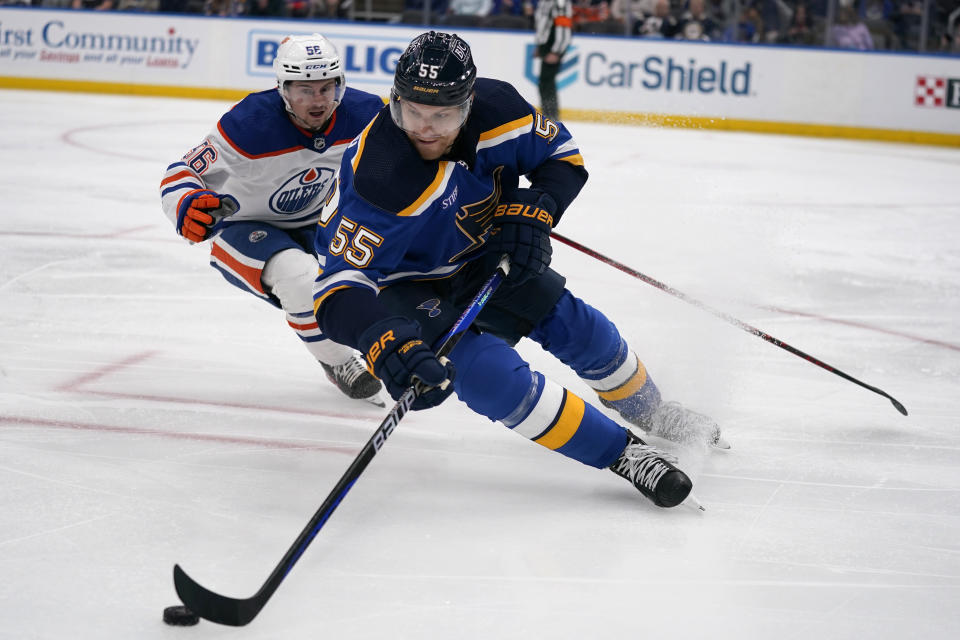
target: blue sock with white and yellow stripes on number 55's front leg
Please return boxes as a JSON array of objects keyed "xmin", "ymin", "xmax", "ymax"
[{"xmin": 450, "ymin": 333, "xmax": 627, "ymax": 469}]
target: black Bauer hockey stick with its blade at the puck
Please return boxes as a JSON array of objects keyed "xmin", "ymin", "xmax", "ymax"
[{"xmin": 173, "ymin": 256, "xmax": 510, "ymax": 627}]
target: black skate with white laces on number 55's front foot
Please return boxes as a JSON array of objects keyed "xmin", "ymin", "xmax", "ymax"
[{"xmin": 610, "ymin": 432, "xmax": 693, "ymax": 508}]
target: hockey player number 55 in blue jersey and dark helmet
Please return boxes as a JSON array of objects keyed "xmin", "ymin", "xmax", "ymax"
[{"xmin": 314, "ymin": 32, "xmax": 719, "ymax": 507}]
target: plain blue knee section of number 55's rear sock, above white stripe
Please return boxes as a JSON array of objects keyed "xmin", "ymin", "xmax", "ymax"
[{"xmin": 530, "ymin": 291, "xmax": 622, "ymax": 377}]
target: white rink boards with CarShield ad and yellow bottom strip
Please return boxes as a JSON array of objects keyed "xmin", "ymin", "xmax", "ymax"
[{"xmin": 0, "ymin": 8, "xmax": 960, "ymax": 146}]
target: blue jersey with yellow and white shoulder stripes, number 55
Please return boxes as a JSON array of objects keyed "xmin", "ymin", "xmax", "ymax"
[{"xmin": 314, "ymin": 78, "xmax": 587, "ymax": 346}]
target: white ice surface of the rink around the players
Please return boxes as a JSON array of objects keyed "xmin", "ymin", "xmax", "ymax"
[{"xmin": 0, "ymin": 91, "xmax": 960, "ymax": 640}]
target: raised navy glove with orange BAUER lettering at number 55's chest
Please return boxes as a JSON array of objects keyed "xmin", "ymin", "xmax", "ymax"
[{"xmin": 487, "ymin": 189, "xmax": 557, "ymax": 285}]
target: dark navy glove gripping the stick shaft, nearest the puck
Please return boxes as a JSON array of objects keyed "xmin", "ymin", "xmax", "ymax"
[{"xmin": 358, "ymin": 316, "xmax": 456, "ymax": 411}]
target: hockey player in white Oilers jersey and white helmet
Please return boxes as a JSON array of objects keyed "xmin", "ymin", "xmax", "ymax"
[{"xmin": 160, "ymin": 34, "xmax": 383, "ymax": 406}]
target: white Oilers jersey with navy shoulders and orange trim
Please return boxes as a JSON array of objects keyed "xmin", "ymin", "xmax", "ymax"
[{"xmin": 160, "ymin": 87, "xmax": 383, "ymax": 229}]
